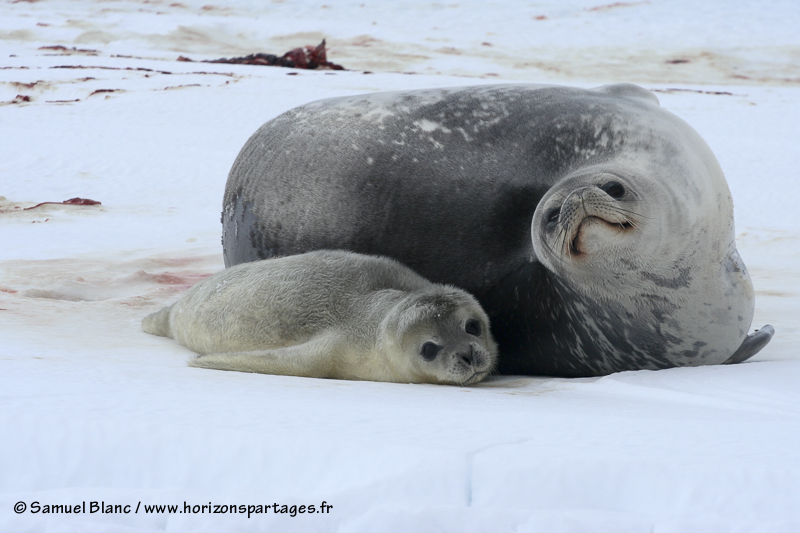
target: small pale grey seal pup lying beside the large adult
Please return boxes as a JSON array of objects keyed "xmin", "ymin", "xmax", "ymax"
[{"xmin": 142, "ymin": 251, "xmax": 497, "ymax": 385}]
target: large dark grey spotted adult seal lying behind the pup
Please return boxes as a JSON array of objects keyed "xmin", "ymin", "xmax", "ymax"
[{"xmin": 222, "ymin": 84, "xmax": 773, "ymax": 376}]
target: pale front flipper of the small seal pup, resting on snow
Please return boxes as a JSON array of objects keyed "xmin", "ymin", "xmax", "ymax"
[{"xmin": 188, "ymin": 335, "xmax": 340, "ymax": 378}]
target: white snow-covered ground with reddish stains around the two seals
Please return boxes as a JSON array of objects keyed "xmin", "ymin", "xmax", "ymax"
[{"xmin": 0, "ymin": 0, "xmax": 800, "ymax": 533}]
